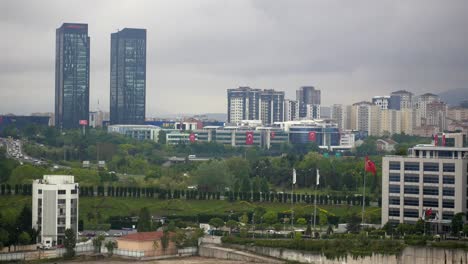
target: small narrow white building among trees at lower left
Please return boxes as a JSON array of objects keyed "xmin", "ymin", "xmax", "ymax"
[{"xmin": 32, "ymin": 175, "xmax": 79, "ymax": 246}]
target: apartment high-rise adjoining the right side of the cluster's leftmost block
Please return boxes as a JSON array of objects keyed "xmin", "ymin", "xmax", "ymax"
[{"xmin": 259, "ymin": 89, "xmax": 284, "ymax": 124}]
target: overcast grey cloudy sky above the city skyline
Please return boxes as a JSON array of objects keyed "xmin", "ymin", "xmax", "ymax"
[{"xmin": 0, "ymin": 0, "xmax": 468, "ymax": 116}]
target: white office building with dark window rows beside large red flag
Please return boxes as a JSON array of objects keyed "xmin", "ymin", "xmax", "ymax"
[{"xmin": 382, "ymin": 133, "xmax": 468, "ymax": 230}]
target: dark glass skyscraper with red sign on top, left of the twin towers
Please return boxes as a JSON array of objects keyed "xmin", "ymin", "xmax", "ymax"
[{"xmin": 55, "ymin": 23, "xmax": 90, "ymax": 129}]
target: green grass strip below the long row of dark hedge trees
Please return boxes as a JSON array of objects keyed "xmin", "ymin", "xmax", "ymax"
[{"xmin": 0, "ymin": 196, "xmax": 380, "ymax": 229}]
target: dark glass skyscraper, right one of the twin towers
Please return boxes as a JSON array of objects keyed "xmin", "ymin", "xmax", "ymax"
[{"xmin": 110, "ymin": 28, "xmax": 146, "ymax": 124}]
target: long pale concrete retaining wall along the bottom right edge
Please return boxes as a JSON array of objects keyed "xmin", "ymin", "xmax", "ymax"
[{"xmin": 229, "ymin": 245, "xmax": 468, "ymax": 264}]
